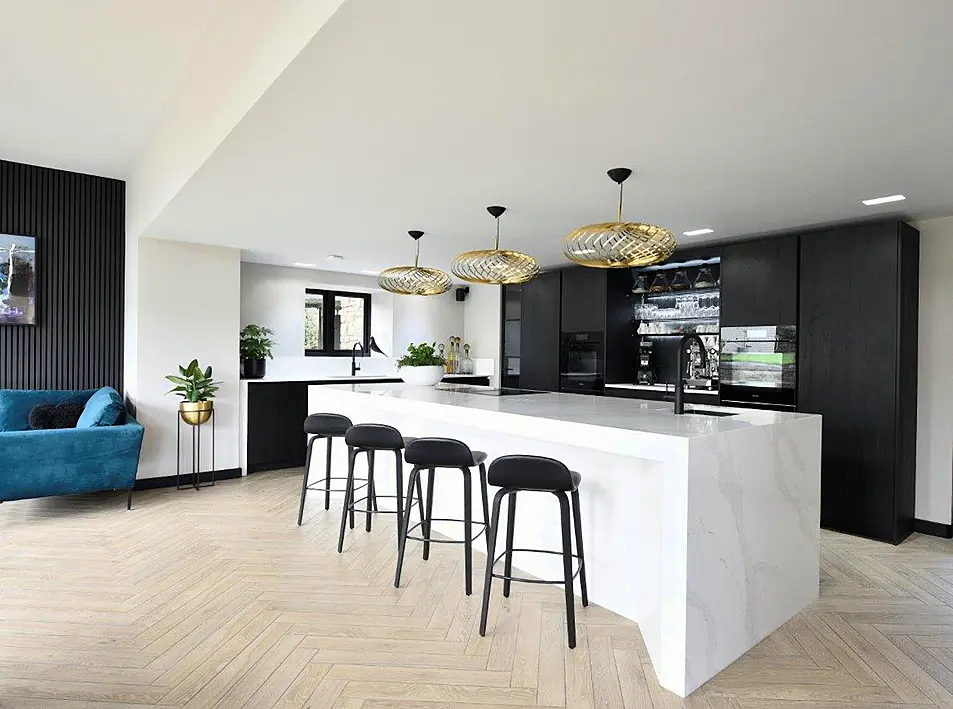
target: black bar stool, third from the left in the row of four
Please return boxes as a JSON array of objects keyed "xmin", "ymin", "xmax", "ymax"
[{"xmin": 394, "ymin": 438, "xmax": 490, "ymax": 596}]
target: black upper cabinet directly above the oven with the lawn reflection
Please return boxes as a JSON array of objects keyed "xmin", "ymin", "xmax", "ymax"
[{"xmin": 721, "ymin": 236, "xmax": 798, "ymax": 327}]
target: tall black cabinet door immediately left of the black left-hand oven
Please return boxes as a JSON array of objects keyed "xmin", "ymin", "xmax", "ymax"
[{"xmin": 519, "ymin": 271, "xmax": 562, "ymax": 391}]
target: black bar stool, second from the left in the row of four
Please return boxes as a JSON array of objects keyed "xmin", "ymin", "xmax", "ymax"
[{"xmin": 338, "ymin": 423, "xmax": 423, "ymax": 553}]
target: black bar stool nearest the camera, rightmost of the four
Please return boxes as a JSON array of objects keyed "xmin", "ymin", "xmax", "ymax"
[{"xmin": 480, "ymin": 455, "xmax": 589, "ymax": 648}]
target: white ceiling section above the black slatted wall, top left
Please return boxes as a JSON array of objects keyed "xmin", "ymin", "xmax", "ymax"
[{"xmin": 0, "ymin": 0, "xmax": 220, "ymax": 177}]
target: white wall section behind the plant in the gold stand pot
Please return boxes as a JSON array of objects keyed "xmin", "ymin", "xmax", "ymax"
[{"xmin": 135, "ymin": 237, "xmax": 241, "ymax": 479}]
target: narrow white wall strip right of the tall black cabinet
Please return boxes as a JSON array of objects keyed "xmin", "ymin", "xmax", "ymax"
[{"xmin": 914, "ymin": 217, "xmax": 953, "ymax": 524}]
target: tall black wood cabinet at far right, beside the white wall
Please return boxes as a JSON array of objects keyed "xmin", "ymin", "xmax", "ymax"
[{"xmin": 800, "ymin": 222, "xmax": 919, "ymax": 544}]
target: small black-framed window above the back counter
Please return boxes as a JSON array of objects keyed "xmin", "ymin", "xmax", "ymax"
[{"xmin": 304, "ymin": 288, "xmax": 371, "ymax": 357}]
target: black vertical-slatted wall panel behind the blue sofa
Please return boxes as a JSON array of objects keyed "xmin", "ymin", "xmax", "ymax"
[{"xmin": 0, "ymin": 160, "xmax": 125, "ymax": 391}]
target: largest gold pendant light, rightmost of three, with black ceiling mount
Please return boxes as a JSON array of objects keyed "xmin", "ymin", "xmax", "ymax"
[{"xmin": 563, "ymin": 167, "xmax": 676, "ymax": 268}]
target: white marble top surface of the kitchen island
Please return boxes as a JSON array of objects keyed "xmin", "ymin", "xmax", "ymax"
[{"xmin": 323, "ymin": 384, "xmax": 812, "ymax": 438}]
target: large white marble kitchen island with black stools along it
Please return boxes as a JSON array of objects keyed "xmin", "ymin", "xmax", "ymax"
[{"xmin": 309, "ymin": 384, "xmax": 821, "ymax": 696}]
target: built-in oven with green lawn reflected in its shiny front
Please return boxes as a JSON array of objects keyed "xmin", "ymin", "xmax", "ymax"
[{"xmin": 718, "ymin": 325, "xmax": 797, "ymax": 411}]
